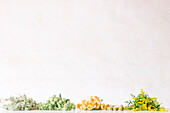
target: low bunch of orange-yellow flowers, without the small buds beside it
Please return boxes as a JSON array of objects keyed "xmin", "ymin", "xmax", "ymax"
[{"xmin": 77, "ymin": 96, "xmax": 110, "ymax": 110}]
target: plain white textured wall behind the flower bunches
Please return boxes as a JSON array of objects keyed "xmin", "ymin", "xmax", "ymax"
[{"xmin": 0, "ymin": 0, "xmax": 170, "ymax": 107}]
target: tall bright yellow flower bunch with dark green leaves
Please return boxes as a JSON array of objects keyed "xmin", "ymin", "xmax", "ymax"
[{"xmin": 125, "ymin": 89, "xmax": 167, "ymax": 111}]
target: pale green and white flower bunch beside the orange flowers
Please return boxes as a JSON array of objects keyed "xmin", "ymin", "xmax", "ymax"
[{"xmin": 40, "ymin": 94, "xmax": 76, "ymax": 111}]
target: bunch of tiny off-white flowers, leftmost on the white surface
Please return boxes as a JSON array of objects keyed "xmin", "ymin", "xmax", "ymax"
[{"xmin": 3, "ymin": 95, "xmax": 39, "ymax": 111}]
